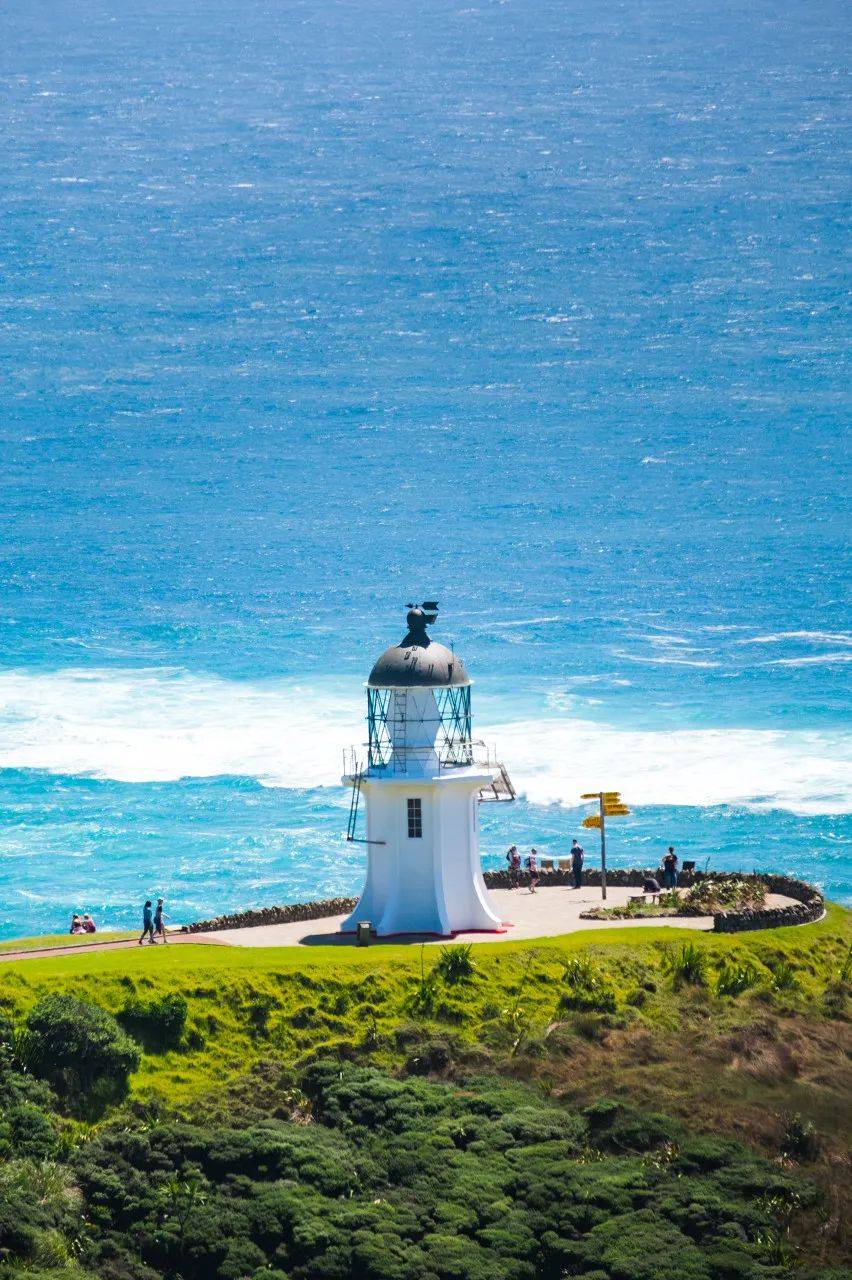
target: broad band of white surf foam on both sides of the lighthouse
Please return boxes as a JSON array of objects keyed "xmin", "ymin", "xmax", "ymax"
[{"xmin": 0, "ymin": 668, "xmax": 852, "ymax": 814}]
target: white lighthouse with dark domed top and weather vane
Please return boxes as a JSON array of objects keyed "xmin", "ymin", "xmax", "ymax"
[{"xmin": 342, "ymin": 600, "xmax": 514, "ymax": 937}]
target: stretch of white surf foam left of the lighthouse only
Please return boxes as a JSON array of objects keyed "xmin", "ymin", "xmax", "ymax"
[{"xmin": 0, "ymin": 668, "xmax": 365, "ymax": 787}]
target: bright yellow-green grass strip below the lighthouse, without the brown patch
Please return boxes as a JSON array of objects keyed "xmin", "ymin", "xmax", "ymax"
[{"xmin": 0, "ymin": 906, "xmax": 852, "ymax": 1103}]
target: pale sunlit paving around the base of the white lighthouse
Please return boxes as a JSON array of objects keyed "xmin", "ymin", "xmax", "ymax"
[{"xmin": 205, "ymin": 886, "xmax": 792, "ymax": 947}]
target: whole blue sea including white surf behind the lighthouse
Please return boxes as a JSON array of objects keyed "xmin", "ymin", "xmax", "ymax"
[{"xmin": 0, "ymin": 0, "xmax": 852, "ymax": 937}]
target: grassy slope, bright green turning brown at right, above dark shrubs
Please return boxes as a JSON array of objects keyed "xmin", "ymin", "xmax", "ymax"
[{"xmin": 0, "ymin": 905, "xmax": 852, "ymax": 1274}]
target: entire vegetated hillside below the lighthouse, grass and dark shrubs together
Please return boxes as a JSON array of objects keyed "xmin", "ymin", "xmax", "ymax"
[{"xmin": 0, "ymin": 906, "xmax": 852, "ymax": 1280}]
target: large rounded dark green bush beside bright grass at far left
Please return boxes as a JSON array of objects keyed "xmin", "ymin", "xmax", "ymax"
[{"xmin": 20, "ymin": 995, "xmax": 139, "ymax": 1111}]
